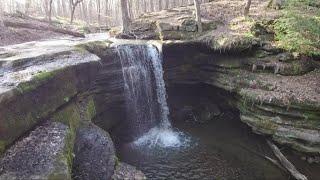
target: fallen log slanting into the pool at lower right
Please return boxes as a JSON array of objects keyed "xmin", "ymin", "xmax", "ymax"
[{"xmin": 267, "ymin": 140, "xmax": 308, "ymax": 180}]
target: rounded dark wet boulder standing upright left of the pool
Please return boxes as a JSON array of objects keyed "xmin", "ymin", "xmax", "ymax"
[{"xmin": 73, "ymin": 124, "xmax": 116, "ymax": 180}]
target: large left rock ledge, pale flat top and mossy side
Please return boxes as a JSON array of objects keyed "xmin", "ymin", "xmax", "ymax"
[{"xmin": 0, "ymin": 41, "xmax": 99, "ymax": 150}]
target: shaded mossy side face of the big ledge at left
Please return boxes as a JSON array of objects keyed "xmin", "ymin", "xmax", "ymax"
[{"xmin": 0, "ymin": 63, "xmax": 98, "ymax": 152}]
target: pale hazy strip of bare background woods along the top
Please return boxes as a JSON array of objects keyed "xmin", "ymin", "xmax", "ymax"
[{"xmin": 0, "ymin": 0, "xmax": 209, "ymax": 27}]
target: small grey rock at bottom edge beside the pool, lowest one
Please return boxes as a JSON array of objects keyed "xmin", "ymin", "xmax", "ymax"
[{"xmin": 112, "ymin": 163, "xmax": 147, "ymax": 180}]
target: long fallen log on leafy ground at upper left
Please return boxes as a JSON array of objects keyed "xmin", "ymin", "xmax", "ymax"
[{"xmin": 3, "ymin": 20, "xmax": 85, "ymax": 37}]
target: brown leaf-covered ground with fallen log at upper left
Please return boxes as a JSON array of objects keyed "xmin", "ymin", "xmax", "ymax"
[{"xmin": 0, "ymin": 12, "xmax": 106, "ymax": 46}]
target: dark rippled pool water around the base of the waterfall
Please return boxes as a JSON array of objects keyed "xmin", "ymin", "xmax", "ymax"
[{"xmin": 118, "ymin": 115, "xmax": 288, "ymax": 180}]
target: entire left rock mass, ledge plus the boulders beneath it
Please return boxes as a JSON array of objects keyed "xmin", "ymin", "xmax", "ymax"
[{"xmin": 0, "ymin": 37, "xmax": 127, "ymax": 179}]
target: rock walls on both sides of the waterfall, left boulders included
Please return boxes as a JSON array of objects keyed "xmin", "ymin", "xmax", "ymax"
[{"xmin": 0, "ymin": 36, "xmax": 320, "ymax": 179}]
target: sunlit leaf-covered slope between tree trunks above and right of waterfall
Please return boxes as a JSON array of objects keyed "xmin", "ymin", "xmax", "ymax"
[{"xmin": 140, "ymin": 0, "xmax": 280, "ymax": 36}]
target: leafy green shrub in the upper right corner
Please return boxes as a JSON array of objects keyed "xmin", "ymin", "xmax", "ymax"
[{"xmin": 274, "ymin": 0, "xmax": 320, "ymax": 57}]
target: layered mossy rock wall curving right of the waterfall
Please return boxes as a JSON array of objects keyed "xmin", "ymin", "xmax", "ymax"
[{"xmin": 163, "ymin": 42, "xmax": 320, "ymax": 153}]
